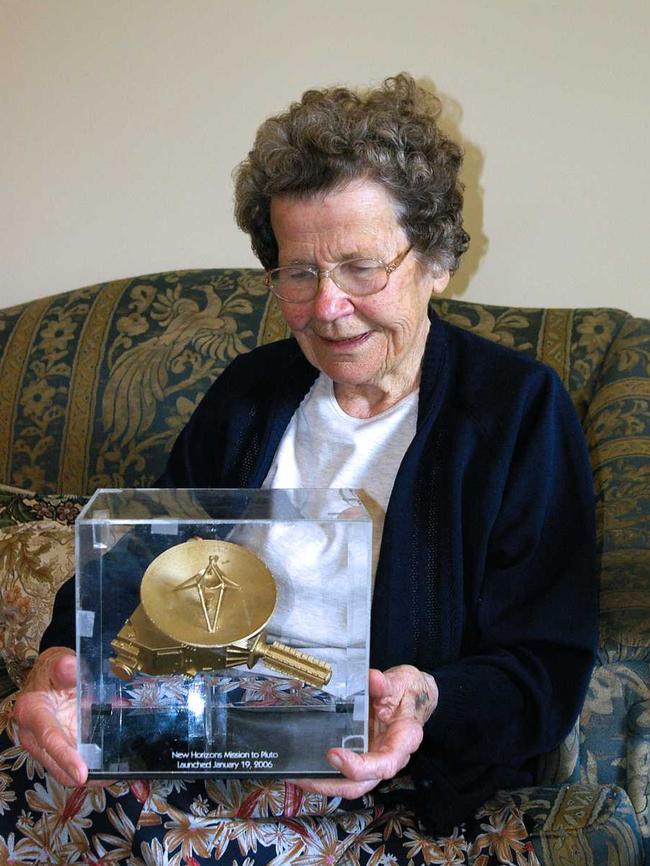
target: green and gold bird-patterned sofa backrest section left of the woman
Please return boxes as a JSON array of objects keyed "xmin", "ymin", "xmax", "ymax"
[{"xmin": 0, "ymin": 271, "xmax": 286, "ymax": 494}]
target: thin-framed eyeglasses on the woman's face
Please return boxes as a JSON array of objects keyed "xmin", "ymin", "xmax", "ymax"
[{"xmin": 264, "ymin": 247, "xmax": 412, "ymax": 304}]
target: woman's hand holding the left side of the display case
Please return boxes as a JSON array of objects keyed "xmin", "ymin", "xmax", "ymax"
[{"xmin": 14, "ymin": 647, "xmax": 88, "ymax": 787}]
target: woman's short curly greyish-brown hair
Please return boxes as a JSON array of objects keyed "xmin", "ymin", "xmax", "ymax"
[{"xmin": 235, "ymin": 73, "xmax": 469, "ymax": 272}]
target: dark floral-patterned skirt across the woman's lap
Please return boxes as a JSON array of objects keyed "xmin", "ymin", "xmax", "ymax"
[{"xmin": 0, "ymin": 698, "xmax": 538, "ymax": 866}]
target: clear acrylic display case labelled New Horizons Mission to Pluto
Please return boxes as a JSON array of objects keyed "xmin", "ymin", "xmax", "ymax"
[{"xmin": 76, "ymin": 489, "xmax": 372, "ymax": 778}]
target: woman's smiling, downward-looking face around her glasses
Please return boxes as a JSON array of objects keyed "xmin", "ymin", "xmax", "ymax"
[{"xmin": 271, "ymin": 179, "xmax": 449, "ymax": 398}]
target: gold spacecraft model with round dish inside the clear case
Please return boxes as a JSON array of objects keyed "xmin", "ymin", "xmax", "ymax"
[{"xmin": 110, "ymin": 538, "xmax": 332, "ymax": 688}]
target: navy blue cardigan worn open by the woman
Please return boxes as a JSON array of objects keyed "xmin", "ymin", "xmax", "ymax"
[{"xmin": 44, "ymin": 313, "xmax": 597, "ymax": 833}]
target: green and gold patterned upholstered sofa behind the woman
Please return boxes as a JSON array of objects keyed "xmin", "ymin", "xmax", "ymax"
[{"xmin": 0, "ymin": 269, "xmax": 650, "ymax": 866}]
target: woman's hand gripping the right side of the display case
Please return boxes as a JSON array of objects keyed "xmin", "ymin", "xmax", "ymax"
[{"xmin": 294, "ymin": 665, "xmax": 438, "ymax": 799}]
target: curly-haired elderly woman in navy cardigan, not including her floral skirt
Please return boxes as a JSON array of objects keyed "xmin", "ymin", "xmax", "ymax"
[{"xmin": 11, "ymin": 75, "xmax": 596, "ymax": 862}]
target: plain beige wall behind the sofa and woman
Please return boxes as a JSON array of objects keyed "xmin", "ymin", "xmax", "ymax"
[{"xmin": 0, "ymin": 0, "xmax": 650, "ymax": 316}]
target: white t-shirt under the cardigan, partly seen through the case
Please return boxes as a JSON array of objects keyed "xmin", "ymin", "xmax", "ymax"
[{"xmin": 233, "ymin": 373, "xmax": 418, "ymax": 690}]
